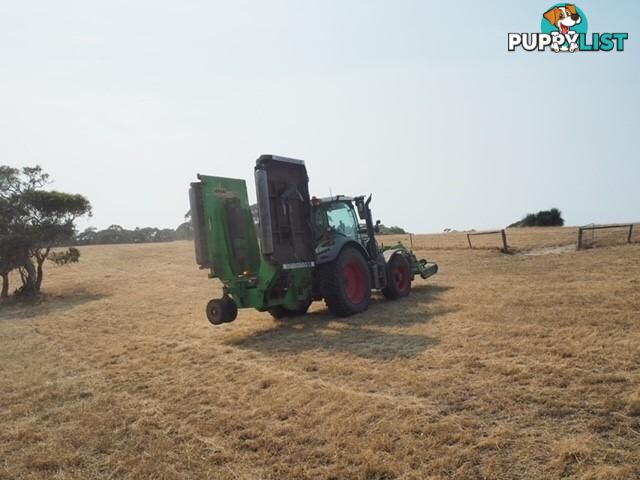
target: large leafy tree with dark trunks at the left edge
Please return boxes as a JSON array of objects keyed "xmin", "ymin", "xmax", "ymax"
[{"xmin": 0, "ymin": 165, "xmax": 91, "ymax": 297}]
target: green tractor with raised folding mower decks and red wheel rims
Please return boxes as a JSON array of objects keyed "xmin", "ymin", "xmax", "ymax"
[{"xmin": 189, "ymin": 155, "xmax": 438, "ymax": 325}]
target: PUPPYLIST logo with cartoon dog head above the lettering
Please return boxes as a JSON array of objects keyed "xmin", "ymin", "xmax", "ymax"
[{"xmin": 508, "ymin": 3, "xmax": 629, "ymax": 53}]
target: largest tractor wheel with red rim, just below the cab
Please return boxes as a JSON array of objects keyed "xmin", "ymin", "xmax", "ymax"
[{"xmin": 322, "ymin": 247, "xmax": 371, "ymax": 317}]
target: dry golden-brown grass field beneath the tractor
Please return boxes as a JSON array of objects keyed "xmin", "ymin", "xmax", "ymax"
[{"xmin": 0, "ymin": 228, "xmax": 640, "ymax": 480}]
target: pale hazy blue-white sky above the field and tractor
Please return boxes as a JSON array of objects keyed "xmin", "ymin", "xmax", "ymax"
[{"xmin": 0, "ymin": 0, "xmax": 640, "ymax": 233}]
